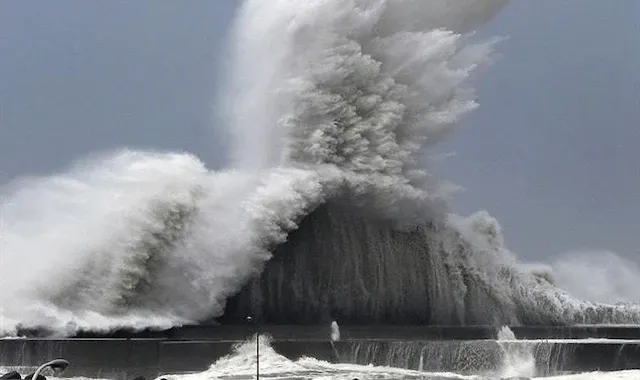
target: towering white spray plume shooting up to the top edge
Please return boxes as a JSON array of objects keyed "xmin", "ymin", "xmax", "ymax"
[{"xmin": 223, "ymin": 0, "xmax": 505, "ymax": 220}]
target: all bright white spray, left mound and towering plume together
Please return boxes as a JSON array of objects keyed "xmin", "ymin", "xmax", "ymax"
[{"xmin": 6, "ymin": 0, "xmax": 636, "ymax": 332}]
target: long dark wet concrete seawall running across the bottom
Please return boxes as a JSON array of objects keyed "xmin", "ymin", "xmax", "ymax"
[{"xmin": 0, "ymin": 326, "xmax": 640, "ymax": 379}]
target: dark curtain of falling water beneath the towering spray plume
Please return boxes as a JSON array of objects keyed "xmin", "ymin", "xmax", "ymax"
[{"xmin": 220, "ymin": 202, "xmax": 533, "ymax": 325}]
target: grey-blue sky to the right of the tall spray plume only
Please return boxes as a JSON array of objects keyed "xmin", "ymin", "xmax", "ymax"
[{"xmin": 441, "ymin": 0, "xmax": 640, "ymax": 261}]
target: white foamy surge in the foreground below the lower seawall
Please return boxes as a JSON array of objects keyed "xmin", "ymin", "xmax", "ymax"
[{"xmin": 158, "ymin": 336, "xmax": 639, "ymax": 380}]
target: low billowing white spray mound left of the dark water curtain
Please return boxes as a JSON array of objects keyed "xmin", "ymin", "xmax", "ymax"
[{"xmin": 0, "ymin": 151, "xmax": 332, "ymax": 333}]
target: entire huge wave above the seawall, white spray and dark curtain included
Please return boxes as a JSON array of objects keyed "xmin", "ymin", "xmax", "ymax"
[{"xmin": 0, "ymin": 0, "xmax": 640, "ymax": 334}]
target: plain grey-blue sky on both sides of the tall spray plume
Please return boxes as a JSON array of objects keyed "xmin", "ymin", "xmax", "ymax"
[{"xmin": 0, "ymin": 0, "xmax": 640, "ymax": 260}]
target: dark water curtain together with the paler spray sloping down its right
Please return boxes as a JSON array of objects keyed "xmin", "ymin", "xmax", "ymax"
[{"xmin": 221, "ymin": 201, "xmax": 640, "ymax": 326}]
